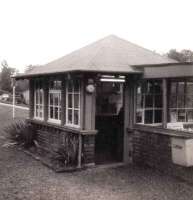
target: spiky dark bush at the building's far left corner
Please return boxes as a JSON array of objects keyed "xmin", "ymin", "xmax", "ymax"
[{"xmin": 5, "ymin": 121, "xmax": 35, "ymax": 148}]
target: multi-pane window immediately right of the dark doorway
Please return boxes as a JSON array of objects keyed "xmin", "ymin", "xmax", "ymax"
[{"xmin": 136, "ymin": 80, "xmax": 162, "ymax": 124}]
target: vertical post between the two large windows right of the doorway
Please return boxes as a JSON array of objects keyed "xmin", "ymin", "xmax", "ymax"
[{"xmin": 162, "ymin": 78, "xmax": 168, "ymax": 128}]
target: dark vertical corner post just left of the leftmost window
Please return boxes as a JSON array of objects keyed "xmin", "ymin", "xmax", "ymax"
[{"xmin": 29, "ymin": 79, "xmax": 34, "ymax": 119}]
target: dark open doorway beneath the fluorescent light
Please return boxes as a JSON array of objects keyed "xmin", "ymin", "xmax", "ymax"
[{"xmin": 95, "ymin": 82, "xmax": 124, "ymax": 164}]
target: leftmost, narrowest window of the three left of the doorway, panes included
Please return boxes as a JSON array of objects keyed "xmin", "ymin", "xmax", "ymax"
[{"xmin": 34, "ymin": 79, "xmax": 44, "ymax": 120}]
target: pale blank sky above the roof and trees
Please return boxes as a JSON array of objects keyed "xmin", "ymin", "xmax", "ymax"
[{"xmin": 0, "ymin": 0, "xmax": 193, "ymax": 72}]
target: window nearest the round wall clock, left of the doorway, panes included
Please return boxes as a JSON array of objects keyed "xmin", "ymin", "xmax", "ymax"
[{"xmin": 66, "ymin": 79, "xmax": 80, "ymax": 127}]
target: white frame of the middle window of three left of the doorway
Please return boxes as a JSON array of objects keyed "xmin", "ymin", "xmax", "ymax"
[{"xmin": 48, "ymin": 89, "xmax": 61, "ymax": 124}]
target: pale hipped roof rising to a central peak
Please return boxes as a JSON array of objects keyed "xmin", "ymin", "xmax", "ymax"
[{"xmin": 18, "ymin": 35, "xmax": 176, "ymax": 77}]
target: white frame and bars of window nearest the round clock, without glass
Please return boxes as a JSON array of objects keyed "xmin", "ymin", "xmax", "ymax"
[{"xmin": 66, "ymin": 80, "xmax": 81, "ymax": 128}]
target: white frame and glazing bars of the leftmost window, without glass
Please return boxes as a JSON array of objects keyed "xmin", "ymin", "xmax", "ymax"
[{"xmin": 34, "ymin": 80, "xmax": 44, "ymax": 121}]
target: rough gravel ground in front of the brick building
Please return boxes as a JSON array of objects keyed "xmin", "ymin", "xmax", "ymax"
[{"xmin": 0, "ymin": 107, "xmax": 193, "ymax": 200}]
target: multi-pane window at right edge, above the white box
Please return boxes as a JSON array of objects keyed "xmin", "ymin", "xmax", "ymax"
[{"xmin": 169, "ymin": 80, "xmax": 193, "ymax": 122}]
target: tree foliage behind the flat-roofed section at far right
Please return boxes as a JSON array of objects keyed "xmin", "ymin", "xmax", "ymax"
[{"xmin": 167, "ymin": 49, "xmax": 193, "ymax": 62}]
